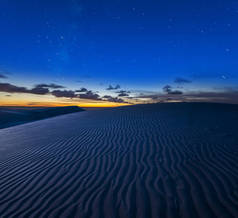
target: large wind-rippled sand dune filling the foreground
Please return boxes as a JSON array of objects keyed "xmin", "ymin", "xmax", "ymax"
[{"xmin": 0, "ymin": 103, "xmax": 238, "ymax": 218}]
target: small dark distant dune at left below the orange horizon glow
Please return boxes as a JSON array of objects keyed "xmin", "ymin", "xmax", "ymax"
[{"xmin": 0, "ymin": 106, "xmax": 84, "ymax": 129}]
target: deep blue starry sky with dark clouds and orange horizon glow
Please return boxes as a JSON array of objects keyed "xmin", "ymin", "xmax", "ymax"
[{"xmin": 0, "ymin": 0, "xmax": 238, "ymax": 107}]
